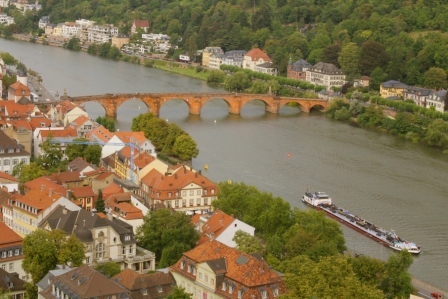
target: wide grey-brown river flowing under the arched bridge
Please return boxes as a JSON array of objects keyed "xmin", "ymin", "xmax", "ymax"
[{"xmin": 0, "ymin": 39, "xmax": 448, "ymax": 290}]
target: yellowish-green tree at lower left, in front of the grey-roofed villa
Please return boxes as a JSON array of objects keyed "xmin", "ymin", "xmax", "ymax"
[{"xmin": 22, "ymin": 229, "xmax": 84, "ymax": 298}]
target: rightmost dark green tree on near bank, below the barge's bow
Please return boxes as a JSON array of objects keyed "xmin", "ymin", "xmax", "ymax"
[{"xmin": 379, "ymin": 250, "xmax": 414, "ymax": 299}]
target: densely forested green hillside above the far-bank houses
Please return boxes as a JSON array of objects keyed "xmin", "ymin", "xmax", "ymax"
[{"xmin": 5, "ymin": 0, "xmax": 448, "ymax": 84}]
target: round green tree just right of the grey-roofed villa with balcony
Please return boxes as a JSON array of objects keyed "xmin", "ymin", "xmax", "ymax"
[{"xmin": 136, "ymin": 209, "xmax": 199, "ymax": 259}]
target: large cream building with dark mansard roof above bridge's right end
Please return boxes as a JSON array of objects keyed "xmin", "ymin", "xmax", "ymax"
[{"xmin": 306, "ymin": 62, "xmax": 347, "ymax": 90}]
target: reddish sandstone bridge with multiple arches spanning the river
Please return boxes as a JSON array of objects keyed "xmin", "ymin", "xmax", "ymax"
[{"xmin": 69, "ymin": 93, "xmax": 329, "ymax": 117}]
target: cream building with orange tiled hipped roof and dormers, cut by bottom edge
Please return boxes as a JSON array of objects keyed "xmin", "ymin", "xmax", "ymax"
[{"xmin": 170, "ymin": 241, "xmax": 286, "ymax": 299}]
